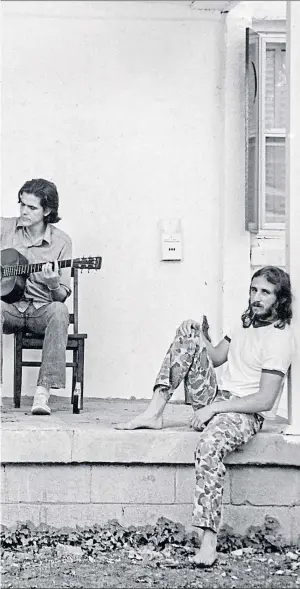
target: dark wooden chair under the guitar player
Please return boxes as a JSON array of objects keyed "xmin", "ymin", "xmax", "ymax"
[{"xmin": 14, "ymin": 267, "xmax": 87, "ymax": 413}]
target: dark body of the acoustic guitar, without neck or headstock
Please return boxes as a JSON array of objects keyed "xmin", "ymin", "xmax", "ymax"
[{"xmin": 1, "ymin": 248, "xmax": 28, "ymax": 303}]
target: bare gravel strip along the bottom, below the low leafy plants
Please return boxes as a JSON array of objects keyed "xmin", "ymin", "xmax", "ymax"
[{"xmin": 1, "ymin": 545, "xmax": 300, "ymax": 589}]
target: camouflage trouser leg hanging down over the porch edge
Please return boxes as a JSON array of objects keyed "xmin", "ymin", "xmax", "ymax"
[{"xmin": 193, "ymin": 402, "xmax": 264, "ymax": 532}]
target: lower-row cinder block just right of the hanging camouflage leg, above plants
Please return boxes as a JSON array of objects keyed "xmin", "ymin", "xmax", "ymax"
[{"xmin": 222, "ymin": 505, "xmax": 295, "ymax": 543}]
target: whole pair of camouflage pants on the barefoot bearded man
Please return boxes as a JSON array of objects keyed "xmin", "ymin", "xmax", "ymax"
[{"xmin": 154, "ymin": 330, "xmax": 264, "ymax": 532}]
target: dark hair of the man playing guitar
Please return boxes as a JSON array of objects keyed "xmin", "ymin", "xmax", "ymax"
[{"xmin": 18, "ymin": 178, "xmax": 60, "ymax": 223}]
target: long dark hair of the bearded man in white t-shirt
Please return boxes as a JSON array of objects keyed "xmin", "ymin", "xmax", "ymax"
[{"xmin": 241, "ymin": 266, "xmax": 293, "ymax": 329}]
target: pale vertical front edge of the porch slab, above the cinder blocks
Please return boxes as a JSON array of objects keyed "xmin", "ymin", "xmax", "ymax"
[{"xmin": 1, "ymin": 424, "xmax": 300, "ymax": 466}]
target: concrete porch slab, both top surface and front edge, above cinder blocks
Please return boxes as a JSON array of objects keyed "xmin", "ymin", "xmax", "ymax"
[{"xmin": 1, "ymin": 397, "xmax": 300, "ymax": 466}]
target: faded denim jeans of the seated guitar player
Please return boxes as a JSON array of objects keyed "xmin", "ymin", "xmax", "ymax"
[{"xmin": 1, "ymin": 301, "xmax": 69, "ymax": 389}]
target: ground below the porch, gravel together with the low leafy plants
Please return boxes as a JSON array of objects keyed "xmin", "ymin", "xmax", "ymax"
[{"xmin": 1, "ymin": 518, "xmax": 300, "ymax": 589}]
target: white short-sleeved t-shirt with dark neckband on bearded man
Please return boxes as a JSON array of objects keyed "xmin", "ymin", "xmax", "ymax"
[{"xmin": 219, "ymin": 323, "xmax": 295, "ymax": 416}]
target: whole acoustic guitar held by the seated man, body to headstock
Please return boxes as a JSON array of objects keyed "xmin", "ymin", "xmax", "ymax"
[{"xmin": 1, "ymin": 248, "xmax": 102, "ymax": 303}]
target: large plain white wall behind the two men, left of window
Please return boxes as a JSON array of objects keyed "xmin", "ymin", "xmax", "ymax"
[{"xmin": 2, "ymin": 1, "xmax": 227, "ymax": 397}]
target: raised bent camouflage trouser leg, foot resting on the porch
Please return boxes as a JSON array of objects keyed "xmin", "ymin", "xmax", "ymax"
[{"xmin": 154, "ymin": 329, "xmax": 217, "ymax": 411}]
